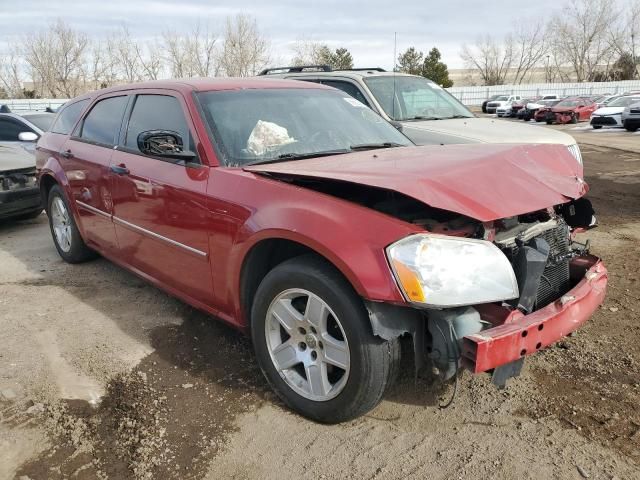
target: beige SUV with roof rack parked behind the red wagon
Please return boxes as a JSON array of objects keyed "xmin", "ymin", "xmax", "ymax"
[{"xmin": 260, "ymin": 65, "xmax": 582, "ymax": 163}]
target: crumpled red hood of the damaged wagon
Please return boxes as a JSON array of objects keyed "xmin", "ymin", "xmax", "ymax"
[{"xmin": 244, "ymin": 144, "xmax": 588, "ymax": 221}]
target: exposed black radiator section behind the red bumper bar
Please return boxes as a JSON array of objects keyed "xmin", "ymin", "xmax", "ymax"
[{"xmin": 536, "ymin": 223, "xmax": 571, "ymax": 309}]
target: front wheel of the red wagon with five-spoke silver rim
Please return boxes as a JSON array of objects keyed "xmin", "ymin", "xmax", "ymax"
[{"xmin": 251, "ymin": 255, "xmax": 400, "ymax": 424}]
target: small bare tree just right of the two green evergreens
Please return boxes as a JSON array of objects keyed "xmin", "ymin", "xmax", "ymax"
[{"xmin": 460, "ymin": 35, "xmax": 515, "ymax": 85}]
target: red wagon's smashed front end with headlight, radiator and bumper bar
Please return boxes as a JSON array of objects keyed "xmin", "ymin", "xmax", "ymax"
[{"xmin": 387, "ymin": 198, "xmax": 607, "ymax": 387}]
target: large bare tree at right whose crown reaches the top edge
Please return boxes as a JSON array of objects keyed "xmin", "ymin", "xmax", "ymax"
[{"xmin": 549, "ymin": 0, "xmax": 619, "ymax": 82}]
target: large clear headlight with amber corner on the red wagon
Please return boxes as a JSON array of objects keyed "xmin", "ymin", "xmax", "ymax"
[{"xmin": 387, "ymin": 234, "xmax": 519, "ymax": 307}]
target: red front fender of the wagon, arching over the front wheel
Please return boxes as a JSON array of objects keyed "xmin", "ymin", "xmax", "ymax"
[{"xmin": 210, "ymin": 169, "xmax": 420, "ymax": 322}]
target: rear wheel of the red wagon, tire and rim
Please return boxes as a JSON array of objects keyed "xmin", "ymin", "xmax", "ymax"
[{"xmin": 47, "ymin": 185, "xmax": 98, "ymax": 263}]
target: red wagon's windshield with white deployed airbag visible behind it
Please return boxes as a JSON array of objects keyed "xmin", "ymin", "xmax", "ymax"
[{"xmin": 197, "ymin": 88, "xmax": 412, "ymax": 166}]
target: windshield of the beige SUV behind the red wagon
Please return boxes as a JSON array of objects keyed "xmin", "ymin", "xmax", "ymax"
[{"xmin": 364, "ymin": 75, "xmax": 473, "ymax": 121}]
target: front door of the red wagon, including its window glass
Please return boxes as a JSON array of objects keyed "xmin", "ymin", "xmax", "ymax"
[{"xmin": 111, "ymin": 90, "xmax": 213, "ymax": 304}]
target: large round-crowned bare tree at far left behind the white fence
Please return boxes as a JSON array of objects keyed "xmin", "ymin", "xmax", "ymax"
[{"xmin": 22, "ymin": 20, "xmax": 89, "ymax": 98}]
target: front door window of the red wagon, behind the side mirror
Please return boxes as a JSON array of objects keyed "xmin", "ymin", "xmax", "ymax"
[{"xmin": 124, "ymin": 95, "xmax": 195, "ymax": 155}]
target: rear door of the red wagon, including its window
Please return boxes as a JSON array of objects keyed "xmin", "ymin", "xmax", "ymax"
[{"xmin": 63, "ymin": 93, "xmax": 129, "ymax": 252}]
